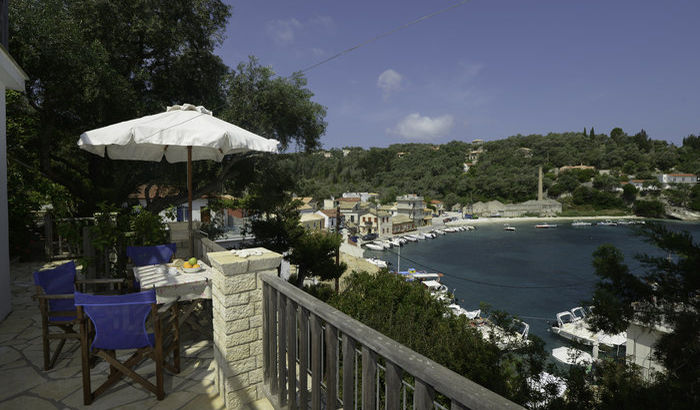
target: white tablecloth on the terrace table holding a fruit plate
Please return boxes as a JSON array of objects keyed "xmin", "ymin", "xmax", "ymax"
[{"xmin": 134, "ymin": 262, "xmax": 212, "ymax": 303}]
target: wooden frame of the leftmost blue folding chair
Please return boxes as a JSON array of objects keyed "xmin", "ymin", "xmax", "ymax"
[{"xmin": 34, "ymin": 279, "xmax": 126, "ymax": 370}]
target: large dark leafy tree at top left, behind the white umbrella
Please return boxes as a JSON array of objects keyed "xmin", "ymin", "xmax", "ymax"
[{"xmin": 9, "ymin": 0, "xmax": 229, "ymax": 213}]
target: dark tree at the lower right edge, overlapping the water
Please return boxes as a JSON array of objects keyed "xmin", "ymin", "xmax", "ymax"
[{"xmin": 592, "ymin": 224, "xmax": 700, "ymax": 408}]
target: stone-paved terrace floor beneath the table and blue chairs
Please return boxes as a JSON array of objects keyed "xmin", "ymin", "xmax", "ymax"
[{"xmin": 0, "ymin": 262, "xmax": 271, "ymax": 410}]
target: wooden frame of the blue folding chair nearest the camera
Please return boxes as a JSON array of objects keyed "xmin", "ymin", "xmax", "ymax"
[{"xmin": 77, "ymin": 303, "xmax": 180, "ymax": 405}]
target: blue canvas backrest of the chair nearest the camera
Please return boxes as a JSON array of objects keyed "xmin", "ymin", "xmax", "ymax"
[{"xmin": 75, "ymin": 289, "xmax": 156, "ymax": 350}]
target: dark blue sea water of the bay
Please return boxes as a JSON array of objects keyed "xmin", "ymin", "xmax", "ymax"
[{"xmin": 365, "ymin": 220, "xmax": 700, "ymax": 350}]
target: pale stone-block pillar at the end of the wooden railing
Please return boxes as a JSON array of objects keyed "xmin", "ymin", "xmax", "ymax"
[{"xmin": 208, "ymin": 248, "xmax": 282, "ymax": 409}]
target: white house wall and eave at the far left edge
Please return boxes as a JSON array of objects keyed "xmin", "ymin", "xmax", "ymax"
[{"xmin": 0, "ymin": 24, "xmax": 29, "ymax": 320}]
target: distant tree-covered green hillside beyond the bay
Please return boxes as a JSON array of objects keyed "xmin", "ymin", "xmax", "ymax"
[{"xmin": 280, "ymin": 128, "xmax": 700, "ymax": 210}]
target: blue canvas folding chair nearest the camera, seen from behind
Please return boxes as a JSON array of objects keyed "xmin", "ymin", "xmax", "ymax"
[{"xmin": 75, "ymin": 289, "xmax": 177, "ymax": 405}]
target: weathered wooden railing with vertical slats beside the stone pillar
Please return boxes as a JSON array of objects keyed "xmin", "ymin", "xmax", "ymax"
[{"xmin": 261, "ymin": 274, "xmax": 521, "ymax": 410}]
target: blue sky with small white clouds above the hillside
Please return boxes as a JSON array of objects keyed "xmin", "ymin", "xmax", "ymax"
[{"xmin": 217, "ymin": 0, "xmax": 700, "ymax": 148}]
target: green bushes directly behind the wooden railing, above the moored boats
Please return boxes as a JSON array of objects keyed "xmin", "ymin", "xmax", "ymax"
[{"xmin": 329, "ymin": 272, "xmax": 546, "ymax": 404}]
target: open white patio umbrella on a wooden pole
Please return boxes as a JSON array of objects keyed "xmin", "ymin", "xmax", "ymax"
[{"xmin": 78, "ymin": 104, "xmax": 279, "ymax": 254}]
